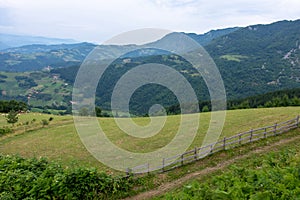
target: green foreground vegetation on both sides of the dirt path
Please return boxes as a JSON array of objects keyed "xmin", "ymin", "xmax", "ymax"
[{"xmin": 0, "ymin": 121, "xmax": 300, "ymax": 199}]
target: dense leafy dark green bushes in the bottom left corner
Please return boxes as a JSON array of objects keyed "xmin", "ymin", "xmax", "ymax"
[{"xmin": 0, "ymin": 155, "xmax": 133, "ymax": 199}]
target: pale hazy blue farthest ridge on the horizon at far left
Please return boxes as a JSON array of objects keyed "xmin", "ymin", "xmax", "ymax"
[{"xmin": 0, "ymin": 33, "xmax": 76, "ymax": 50}]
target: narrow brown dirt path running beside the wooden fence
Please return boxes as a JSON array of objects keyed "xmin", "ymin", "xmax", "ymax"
[{"xmin": 125, "ymin": 136, "xmax": 300, "ymax": 200}]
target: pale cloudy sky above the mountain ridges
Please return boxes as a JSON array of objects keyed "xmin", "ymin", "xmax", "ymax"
[{"xmin": 0, "ymin": 0, "xmax": 300, "ymax": 43}]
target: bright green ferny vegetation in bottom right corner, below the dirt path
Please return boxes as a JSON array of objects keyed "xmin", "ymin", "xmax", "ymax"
[{"xmin": 157, "ymin": 132, "xmax": 300, "ymax": 200}]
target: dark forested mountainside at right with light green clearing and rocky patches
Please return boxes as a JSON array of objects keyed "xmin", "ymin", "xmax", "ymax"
[{"xmin": 205, "ymin": 20, "xmax": 300, "ymax": 98}]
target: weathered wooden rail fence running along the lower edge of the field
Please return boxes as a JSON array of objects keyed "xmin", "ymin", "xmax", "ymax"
[{"xmin": 127, "ymin": 116, "xmax": 300, "ymax": 174}]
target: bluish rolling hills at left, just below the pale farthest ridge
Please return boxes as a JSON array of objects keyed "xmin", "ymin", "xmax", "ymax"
[{"xmin": 0, "ymin": 43, "xmax": 96, "ymax": 72}]
